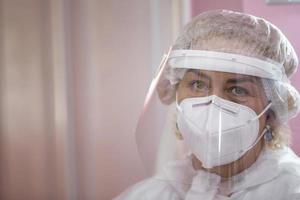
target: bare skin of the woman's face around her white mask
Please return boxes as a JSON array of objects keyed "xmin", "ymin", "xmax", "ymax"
[{"xmin": 177, "ymin": 70, "xmax": 268, "ymax": 177}]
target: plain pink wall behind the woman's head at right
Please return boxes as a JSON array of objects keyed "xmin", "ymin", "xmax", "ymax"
[{"xmin": 191, "ymin": 0, "xmax": 300, "ymax": 155}]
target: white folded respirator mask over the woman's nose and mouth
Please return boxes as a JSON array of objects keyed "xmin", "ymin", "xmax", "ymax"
[{"xmin": 176, "ymin": 95, "xmax": 271, "ymax": 169}]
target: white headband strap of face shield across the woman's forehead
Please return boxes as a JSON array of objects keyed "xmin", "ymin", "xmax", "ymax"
[{"xmin": 168, "ymin": 50, "xmax": 284, "ymax": 81}]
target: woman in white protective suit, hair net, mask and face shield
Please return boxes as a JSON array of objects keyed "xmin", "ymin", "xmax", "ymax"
[{"xmin": 116, "ymin": 10, "xmax": 300, "ymax": 200}]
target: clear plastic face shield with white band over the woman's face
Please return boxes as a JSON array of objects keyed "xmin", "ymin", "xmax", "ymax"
[{"xmin": 136, "ymin": 50, "xmax": 290, "ymax": 191}]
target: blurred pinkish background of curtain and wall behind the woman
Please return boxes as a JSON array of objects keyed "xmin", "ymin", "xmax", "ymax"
[{"xmin": 0, "ymin": 0, "xmax": 300, "ymax": 200}]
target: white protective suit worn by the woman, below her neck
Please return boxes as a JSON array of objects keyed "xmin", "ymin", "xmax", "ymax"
[{"xmin": 114, "ymin": 147, "xmax": 300, "ymax": 200}]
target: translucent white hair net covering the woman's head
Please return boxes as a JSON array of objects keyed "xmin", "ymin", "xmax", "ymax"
[{"xmin": 162, "ymin": 10, "xmax": 300, "ymax": 121}]
